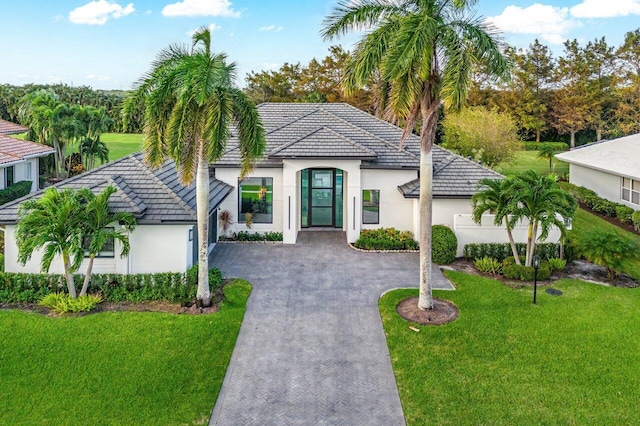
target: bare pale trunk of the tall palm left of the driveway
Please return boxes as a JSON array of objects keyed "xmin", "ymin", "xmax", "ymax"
[{"xmin": 196, "ymin": 141, "xmax": 211, "ymax": 306}]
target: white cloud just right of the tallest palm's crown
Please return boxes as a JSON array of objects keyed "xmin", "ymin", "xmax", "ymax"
[{"xmin": 487, "ymin": 3, "xmax": 582, "ymax": 44}]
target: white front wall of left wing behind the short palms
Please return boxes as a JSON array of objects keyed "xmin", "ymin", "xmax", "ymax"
[{"xmin": 5, "ymin": 225, "xmax": 191, "ymax": 274}]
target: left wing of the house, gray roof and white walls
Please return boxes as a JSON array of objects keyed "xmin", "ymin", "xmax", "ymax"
[{"xmin": 0, "ymin": 154, "xmax": 233, "ymax": 274}]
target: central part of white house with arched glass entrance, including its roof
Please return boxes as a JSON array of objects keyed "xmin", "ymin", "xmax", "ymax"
[{"xmin": 212, "ymin": 103, "xmax": 506, "ymax": 253}]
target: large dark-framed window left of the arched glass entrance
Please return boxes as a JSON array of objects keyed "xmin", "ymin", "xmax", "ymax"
[{"xmin": 238, "ymin": 177, "xmax": 273, "ymax": 223}]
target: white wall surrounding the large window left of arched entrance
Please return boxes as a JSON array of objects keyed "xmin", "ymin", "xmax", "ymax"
[{"xmin": 216, "ymin": 167, "xmax": 283, "ymax": 236}]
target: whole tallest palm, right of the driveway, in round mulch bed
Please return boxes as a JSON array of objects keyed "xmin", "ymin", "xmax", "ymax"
[{"xmin": 322, "ymin": 0, "xmax": 508, "ymax": 309}]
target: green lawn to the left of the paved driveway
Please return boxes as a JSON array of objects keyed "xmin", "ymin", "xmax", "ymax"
[{"xmin": 0, "ymin": 280, "xmax": 251, "ymax": 425}]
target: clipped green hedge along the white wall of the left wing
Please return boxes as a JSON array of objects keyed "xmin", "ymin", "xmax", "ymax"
[{"xmin": 0, "ymin": 265, "xmax": 222, "ymax": 303}]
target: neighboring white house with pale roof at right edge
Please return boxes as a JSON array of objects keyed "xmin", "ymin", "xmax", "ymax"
[{"xmin": 556, "ymin": 133, "xmax": 640, "ymax": 210}]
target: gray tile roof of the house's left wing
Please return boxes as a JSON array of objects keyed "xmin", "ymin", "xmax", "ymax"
[{"xmin": 0, "ymin": 153, "xmax": 233, "ymax": 224}]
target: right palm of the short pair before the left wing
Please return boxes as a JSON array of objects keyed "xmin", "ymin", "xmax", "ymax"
[{"xmin": 80, "ymin": 185, "xmax": 136, "ymax": 296}]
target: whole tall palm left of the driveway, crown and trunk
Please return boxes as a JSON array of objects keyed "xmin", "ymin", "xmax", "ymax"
[{"xmin": 123, "ymin": 28, "xmax": 265, "ymax": 306}]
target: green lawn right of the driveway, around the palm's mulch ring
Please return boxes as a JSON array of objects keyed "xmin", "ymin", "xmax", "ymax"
[{"xmin": 380, "ymin": 272, "xmax": 640, "ymax": 425}]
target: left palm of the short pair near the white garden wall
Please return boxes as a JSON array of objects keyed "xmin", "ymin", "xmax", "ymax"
[{"xmin": 471, "ymin": 178, "xmax": 521, "ymax": 265}]
